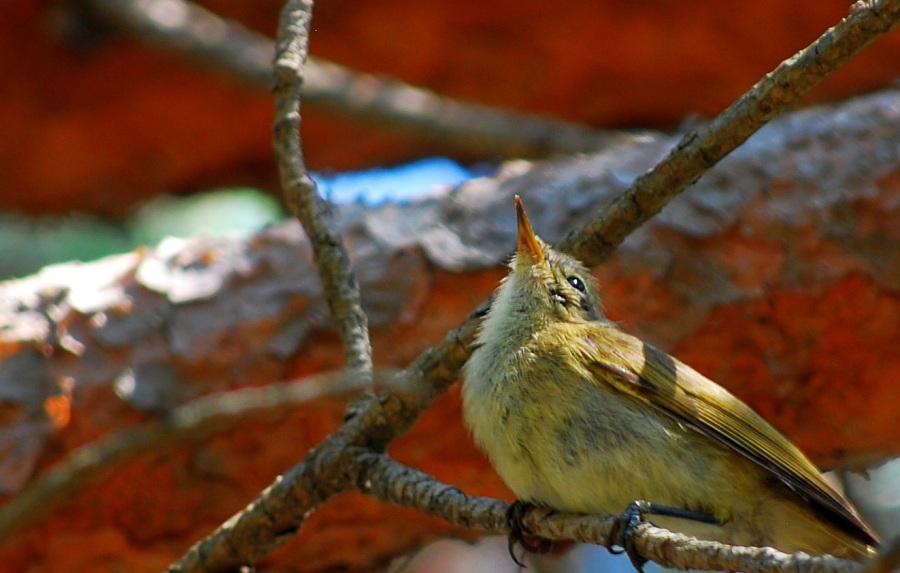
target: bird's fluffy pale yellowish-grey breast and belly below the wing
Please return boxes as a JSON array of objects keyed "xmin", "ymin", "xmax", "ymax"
[{"xmin": 463, "ymin": 342, "xmax": 744, "ymax": 513}]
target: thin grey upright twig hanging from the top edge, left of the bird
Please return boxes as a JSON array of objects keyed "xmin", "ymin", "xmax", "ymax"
[{"xmin": 274, "ymin": 0, "xmax": 372, "ymax": 373}]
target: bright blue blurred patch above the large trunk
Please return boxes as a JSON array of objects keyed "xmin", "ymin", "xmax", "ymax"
[{"xmin": 312, "ymin": 157, "xmax": 474, "ymax": 205}]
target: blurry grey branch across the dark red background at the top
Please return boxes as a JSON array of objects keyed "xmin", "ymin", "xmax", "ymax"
[{"xmin": 87, "ymin": 0, "xmax": 635, "ymax": 157}]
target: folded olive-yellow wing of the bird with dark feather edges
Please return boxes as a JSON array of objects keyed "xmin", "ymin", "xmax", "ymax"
[{"xmin": 582, "ymin": 323, "xmax": 878, "ymax": 545}]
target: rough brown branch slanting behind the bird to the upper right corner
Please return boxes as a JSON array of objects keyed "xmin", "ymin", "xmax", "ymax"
[{"xmin": 170, "ymin": 0, "xmax": 900, "ymax": 571}]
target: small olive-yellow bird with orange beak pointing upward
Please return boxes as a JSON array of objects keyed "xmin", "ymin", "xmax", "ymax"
[{"xmin": 462, "ymin": 196, "xmax": 878, "ymax": 568}]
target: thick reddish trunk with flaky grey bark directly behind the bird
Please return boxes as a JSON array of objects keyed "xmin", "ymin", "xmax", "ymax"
[{"xmin": 0, "ymin": 87, "xmax": 900, "ymax": 571}]
